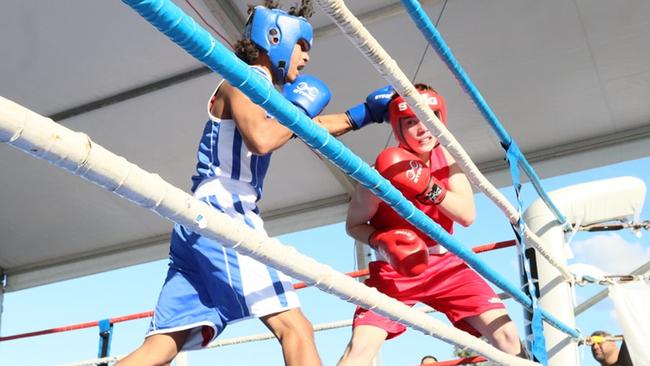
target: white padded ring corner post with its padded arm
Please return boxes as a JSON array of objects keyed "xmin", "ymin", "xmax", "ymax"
[{"xmin": 523, "ymin": 177, "xmax": 646, "ymax": 366}]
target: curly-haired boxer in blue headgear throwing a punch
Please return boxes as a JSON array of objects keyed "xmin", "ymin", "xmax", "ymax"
[{"xmin": 119, "ymin": 6, "xmax": 392, "ymax": 366}]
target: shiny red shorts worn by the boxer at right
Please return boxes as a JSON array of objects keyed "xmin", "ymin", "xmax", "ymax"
[{"xmin": 352, "ymin": 253, "xmax": 505, "ymax": 339}]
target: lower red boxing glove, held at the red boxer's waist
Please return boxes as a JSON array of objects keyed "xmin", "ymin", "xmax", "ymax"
[{"xmin": 368, "ymin": 229, "xmax": 429, "ymax": 277}]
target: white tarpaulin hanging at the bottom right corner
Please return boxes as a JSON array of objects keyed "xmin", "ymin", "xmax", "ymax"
[{"xmin": 609, "ymin": 280, "xmax": 650, "ymax": 366}]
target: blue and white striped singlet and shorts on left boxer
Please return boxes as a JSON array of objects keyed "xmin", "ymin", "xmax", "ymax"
[{"xmin": 148, "ymin": 67, "xmax": 300, "ymax": 349}]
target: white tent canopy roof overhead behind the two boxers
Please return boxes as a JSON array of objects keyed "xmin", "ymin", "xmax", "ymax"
[{"xmin": 0, "ymin": 0, "xmax": 650, "ymax": 291}]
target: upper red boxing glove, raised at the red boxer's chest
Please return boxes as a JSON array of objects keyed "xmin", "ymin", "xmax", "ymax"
[{"xmin": 375, "ymin": 147, "xmax": 447, "ymax": 205}]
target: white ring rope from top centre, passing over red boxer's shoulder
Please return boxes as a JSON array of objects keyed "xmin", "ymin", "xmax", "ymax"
[{"xmin": 316, "ymin": 0, "xmax": 574, "ymax": 282}]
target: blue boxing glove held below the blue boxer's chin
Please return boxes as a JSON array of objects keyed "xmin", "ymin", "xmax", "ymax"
[{"xmin": 282, "ymin": 75, "xmax": 332, "ymax": 118}]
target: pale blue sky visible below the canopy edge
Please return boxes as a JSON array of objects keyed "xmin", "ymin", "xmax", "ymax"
[{"xmin": 0, "ymin": 158, "xmax": 650, "ymax": 366}]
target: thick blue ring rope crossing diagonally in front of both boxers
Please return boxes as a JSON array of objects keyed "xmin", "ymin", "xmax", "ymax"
[{"xmin": 122, "ymin": 0, "xmax": 579, "ymax": 338}]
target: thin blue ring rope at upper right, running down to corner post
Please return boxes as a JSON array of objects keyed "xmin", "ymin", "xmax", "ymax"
[{"xmin": 402, "ymin": 0, "xmax": 569, "ymax": 227}]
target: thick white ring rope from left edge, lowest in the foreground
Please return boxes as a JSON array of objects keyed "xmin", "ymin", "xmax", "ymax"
[{"xmin": 0, "ymin": 97, "xmax": 535, "ymax": 365}]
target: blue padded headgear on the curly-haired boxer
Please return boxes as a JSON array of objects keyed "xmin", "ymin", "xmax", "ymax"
[{"xmin": 244, "ymin": 6, "xmax": 314, "ymax": 83}]
